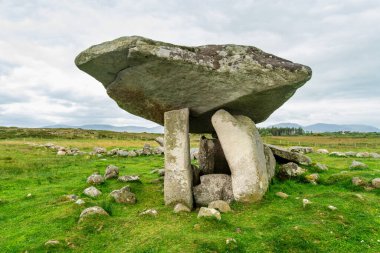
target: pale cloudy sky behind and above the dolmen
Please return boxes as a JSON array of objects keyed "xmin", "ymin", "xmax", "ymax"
[{"xmin": 0, "ymin": 0, "xmax": 380, "ymax": 127}]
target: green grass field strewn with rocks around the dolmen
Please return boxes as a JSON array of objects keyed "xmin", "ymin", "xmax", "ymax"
[{"xmin": 0, "ymin": 129, "xmax": 380, "ymax": 252}]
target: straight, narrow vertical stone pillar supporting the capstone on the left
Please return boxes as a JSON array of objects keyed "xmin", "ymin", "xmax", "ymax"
[{"xmin": 164, "ymin": 108, "xmax": 193, "ymax": 209}]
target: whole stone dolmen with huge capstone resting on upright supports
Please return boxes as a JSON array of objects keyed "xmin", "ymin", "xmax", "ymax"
[{"xmin": 75, "ymin": 36, "xmax": 312, "ymax": 209}]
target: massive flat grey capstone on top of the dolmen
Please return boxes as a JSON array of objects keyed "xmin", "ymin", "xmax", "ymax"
[{"xmin": 75, "ymin": 36, "xmax": 311, "ymax": 133}]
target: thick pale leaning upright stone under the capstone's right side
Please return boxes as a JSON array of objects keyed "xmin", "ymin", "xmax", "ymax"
[{"xmin": 211, "ymin": 110, "xmax": 269, "ymax": 201}]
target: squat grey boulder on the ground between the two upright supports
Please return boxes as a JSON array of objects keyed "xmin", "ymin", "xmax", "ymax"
[{"xmin": 193, "ymin": 174, "xmax": 234, "ymax": 206}]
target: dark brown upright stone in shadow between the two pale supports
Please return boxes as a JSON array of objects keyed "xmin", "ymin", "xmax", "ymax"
[{"xmin": 198, "ymin": 136, "xmax": 231, "ymax": 174}]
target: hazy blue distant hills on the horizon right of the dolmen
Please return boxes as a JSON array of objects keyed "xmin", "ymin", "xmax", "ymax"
[{"xmin": 269, "ymin": 123, "xmax": 380, "ymax": 133}]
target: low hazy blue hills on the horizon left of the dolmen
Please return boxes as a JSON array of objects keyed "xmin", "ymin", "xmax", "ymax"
[{"xmin": 42, "ymin": 124, "xmax": 164, "ymax": 133}]
